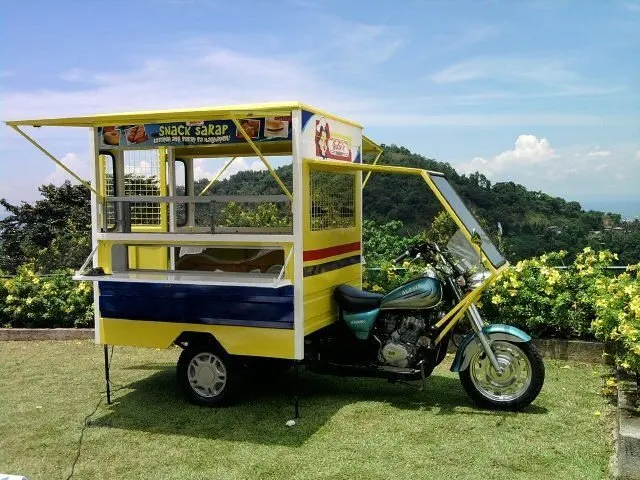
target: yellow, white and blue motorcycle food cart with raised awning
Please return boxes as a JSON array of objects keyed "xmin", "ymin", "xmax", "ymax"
[{"xmin": 7, "ymin": 102, "xmax": 542, "ymax": 408}]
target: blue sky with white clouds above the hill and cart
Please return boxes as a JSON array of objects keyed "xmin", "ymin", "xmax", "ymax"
[{"xmin": 0, "ymin": 0, "xmax": 640, "ymax": 212}]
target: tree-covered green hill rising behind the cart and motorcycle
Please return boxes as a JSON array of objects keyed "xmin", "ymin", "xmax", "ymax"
[{"xmin": 199, "ymin": 145, "xmax": 640, "ymax": 263}]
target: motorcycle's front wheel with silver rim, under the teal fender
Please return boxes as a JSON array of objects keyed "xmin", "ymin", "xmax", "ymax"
[{"xmin": 460, "ymin": 340, "xmax": 544, "ymax": 410}]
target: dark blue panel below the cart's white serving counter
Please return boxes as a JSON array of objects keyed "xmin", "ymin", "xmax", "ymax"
[{"xmin": 99, "ymin": 282, "xmax": 293, "ymax": 329}]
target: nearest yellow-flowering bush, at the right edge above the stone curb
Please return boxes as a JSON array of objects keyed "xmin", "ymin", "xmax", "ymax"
[{"xmin": 593, "ymin": 264, "xmax": 640, "ymax": 375}]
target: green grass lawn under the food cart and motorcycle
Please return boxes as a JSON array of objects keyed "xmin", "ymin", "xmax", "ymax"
[{"xmin": 0, "ymin": 341, "xmax": 612, "ymax": 480}]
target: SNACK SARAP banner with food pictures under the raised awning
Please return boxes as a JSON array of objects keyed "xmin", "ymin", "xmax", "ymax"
[{"xmin": 98, "ymin": 117, "xmax": 291, "ymax": 148}]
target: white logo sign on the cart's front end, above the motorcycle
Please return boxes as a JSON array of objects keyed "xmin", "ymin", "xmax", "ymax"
[{"xmin": 302, "ymin": 110, "xmax": 362, "ymax": 163}]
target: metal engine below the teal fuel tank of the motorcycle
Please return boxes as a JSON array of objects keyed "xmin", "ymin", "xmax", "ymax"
[{"xmin": 380, "ymin": 315, "xmax": 426, "ymax": 367}]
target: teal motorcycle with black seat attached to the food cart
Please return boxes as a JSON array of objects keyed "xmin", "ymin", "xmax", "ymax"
[{"xmin": 305, "ymin": 230, "xmax": 545, "ymax": 410}]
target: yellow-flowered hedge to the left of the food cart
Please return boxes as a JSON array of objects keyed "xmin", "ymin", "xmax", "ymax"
[{"xmin": 0, "ymin": 264, "xmax": 93, "ymax": 328}]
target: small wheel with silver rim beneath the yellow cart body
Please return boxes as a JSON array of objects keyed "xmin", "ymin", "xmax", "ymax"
[{"xmin": 177, "ymin": 345, "xmax": 242, "ymax": 407}]
